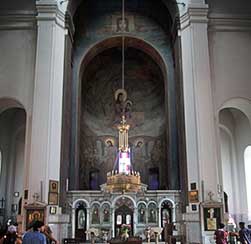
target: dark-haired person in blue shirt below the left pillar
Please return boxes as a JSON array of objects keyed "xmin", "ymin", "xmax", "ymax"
[{"xmin": 23, "ymin": 221, "xmax": 46, "ymax": 244}]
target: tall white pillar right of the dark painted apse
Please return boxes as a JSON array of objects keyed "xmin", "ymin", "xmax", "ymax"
[{"xmin": 180, "ymin": 1, "xmax": 218, "ymax": 243}]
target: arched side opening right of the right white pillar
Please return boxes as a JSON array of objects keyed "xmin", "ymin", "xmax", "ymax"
[{"xmin": 219, "ymin": 106, "xmax": 251, "ymax": 223}]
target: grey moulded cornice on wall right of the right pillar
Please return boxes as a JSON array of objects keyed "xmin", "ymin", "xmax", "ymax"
[{"xmin": 209, "ymin": 13, "xmax": 251, "ymax": 32}]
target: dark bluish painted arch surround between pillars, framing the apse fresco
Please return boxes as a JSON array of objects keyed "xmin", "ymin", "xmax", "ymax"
[{"xmin": 65, "ymin": 0, "xmax": 186, "ymax": 192}]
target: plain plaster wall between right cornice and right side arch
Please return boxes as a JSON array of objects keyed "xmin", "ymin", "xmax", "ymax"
[{"xmin": 209, "ymin": 30, "xmax": 251, "ymax": 110}]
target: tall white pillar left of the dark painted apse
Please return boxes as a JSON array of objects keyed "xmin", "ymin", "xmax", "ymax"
[{"xmin": 28, "ymin": 0, "xmax": 65, "ymax": 206}]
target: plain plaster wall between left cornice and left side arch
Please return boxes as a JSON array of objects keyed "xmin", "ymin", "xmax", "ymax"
[{"xmin": 0, "ymin": 28, "xmax": 36, "ymax": 113}]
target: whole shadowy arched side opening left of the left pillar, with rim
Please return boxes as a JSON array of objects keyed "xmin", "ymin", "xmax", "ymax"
[{"xmin": 0, "ymin": 102, "xmax": 26, "ymax": 223}]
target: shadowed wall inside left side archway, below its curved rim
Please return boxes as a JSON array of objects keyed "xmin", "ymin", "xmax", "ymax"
[{"xmin": 0, "ymin": 109, "xmax": 25, "ymax": 217}]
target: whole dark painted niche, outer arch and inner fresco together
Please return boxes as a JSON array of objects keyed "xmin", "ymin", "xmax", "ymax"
[{"xmin": 70, "ymin": 0, "xmax": 179, "ymax": 189}]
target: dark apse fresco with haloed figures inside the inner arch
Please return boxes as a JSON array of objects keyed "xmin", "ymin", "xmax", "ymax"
[{"xmin": 80, "ymin": 48, "xmax": 167, "ymax": 189}]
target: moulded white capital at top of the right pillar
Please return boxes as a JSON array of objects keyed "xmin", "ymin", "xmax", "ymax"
[{"xmin": 180, "ymin": 4, "xmax": 208, "ymax": 30}]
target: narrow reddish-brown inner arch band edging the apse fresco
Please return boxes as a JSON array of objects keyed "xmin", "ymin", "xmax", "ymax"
[{"xmin": 76, "ymin": 35, "xmax": 171, "ymax": 189}]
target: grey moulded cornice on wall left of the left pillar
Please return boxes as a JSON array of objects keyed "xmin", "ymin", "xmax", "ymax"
[{"xmin": 0, "ymin": 11, "xmax": 36, "ymax": 30}]
